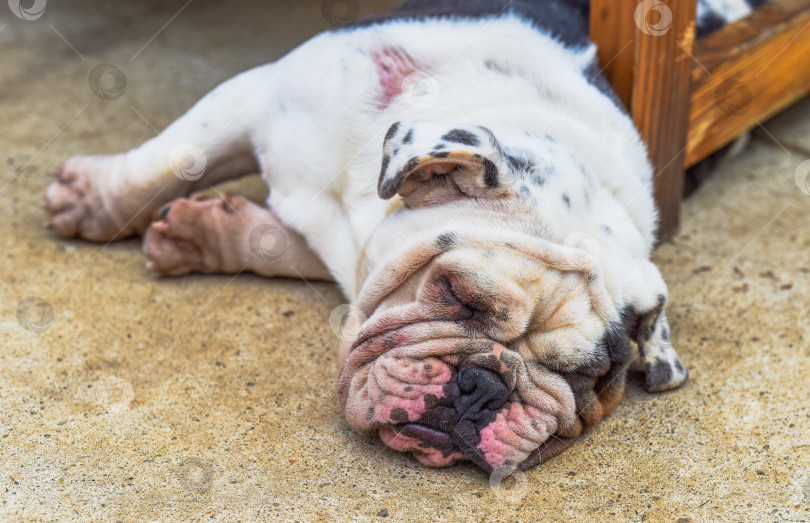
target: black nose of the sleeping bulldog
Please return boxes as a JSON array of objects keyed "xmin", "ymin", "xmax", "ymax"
[{"xmin": 456, "ymin": 367, "xmax": 509, "ymax": 421}]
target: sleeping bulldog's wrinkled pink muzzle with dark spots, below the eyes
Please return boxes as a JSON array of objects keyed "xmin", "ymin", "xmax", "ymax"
[{"xmin": 338, "ymin": 288, "xmax": 574, "ymax": 470}]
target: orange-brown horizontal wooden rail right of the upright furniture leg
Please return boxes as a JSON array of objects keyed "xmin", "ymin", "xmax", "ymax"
[{"xmin": 685, "ymin": 0, "xmax": 810, "ymax": 166}]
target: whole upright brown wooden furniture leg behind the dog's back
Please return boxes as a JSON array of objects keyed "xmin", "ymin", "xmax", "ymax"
[{"xmin": 591, "ymin": 0, "xmax": 697, "ymax": 240}]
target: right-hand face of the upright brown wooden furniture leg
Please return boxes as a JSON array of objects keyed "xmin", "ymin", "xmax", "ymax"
[{"xmin": 631, "ymin": 0, "xmax": 697, "ymax": 240}]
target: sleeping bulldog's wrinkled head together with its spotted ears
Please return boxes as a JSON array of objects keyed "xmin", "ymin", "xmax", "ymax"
[{"xmin": 338, "ymin": 123, "xmax": 686, "ymax": 473}]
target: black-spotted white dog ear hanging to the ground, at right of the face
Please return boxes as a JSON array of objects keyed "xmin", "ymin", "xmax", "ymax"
[{"xmin": 624, "ymin": 261, "xmax": 689, "ymax": 392}]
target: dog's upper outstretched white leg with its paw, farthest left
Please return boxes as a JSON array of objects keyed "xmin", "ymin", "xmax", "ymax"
[{"xmin": 43, "ymin": 66, "xmax": 269, "ymax": 241}]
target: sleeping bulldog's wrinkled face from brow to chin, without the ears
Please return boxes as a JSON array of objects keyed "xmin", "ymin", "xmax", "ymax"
[{"xmin": 340, "ymin": 233, "xmax": 630, "ymax": 471}]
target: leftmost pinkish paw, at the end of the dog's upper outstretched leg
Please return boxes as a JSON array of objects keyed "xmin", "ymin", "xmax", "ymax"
[{"xmin": 42, "ymin": 156, "xmax": 136, "ymax": 242}]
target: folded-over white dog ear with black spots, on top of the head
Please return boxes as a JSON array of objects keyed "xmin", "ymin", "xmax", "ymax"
[{"xmin": 377, "ymin": 122, "xmax": 513, "ymax": 207}]
